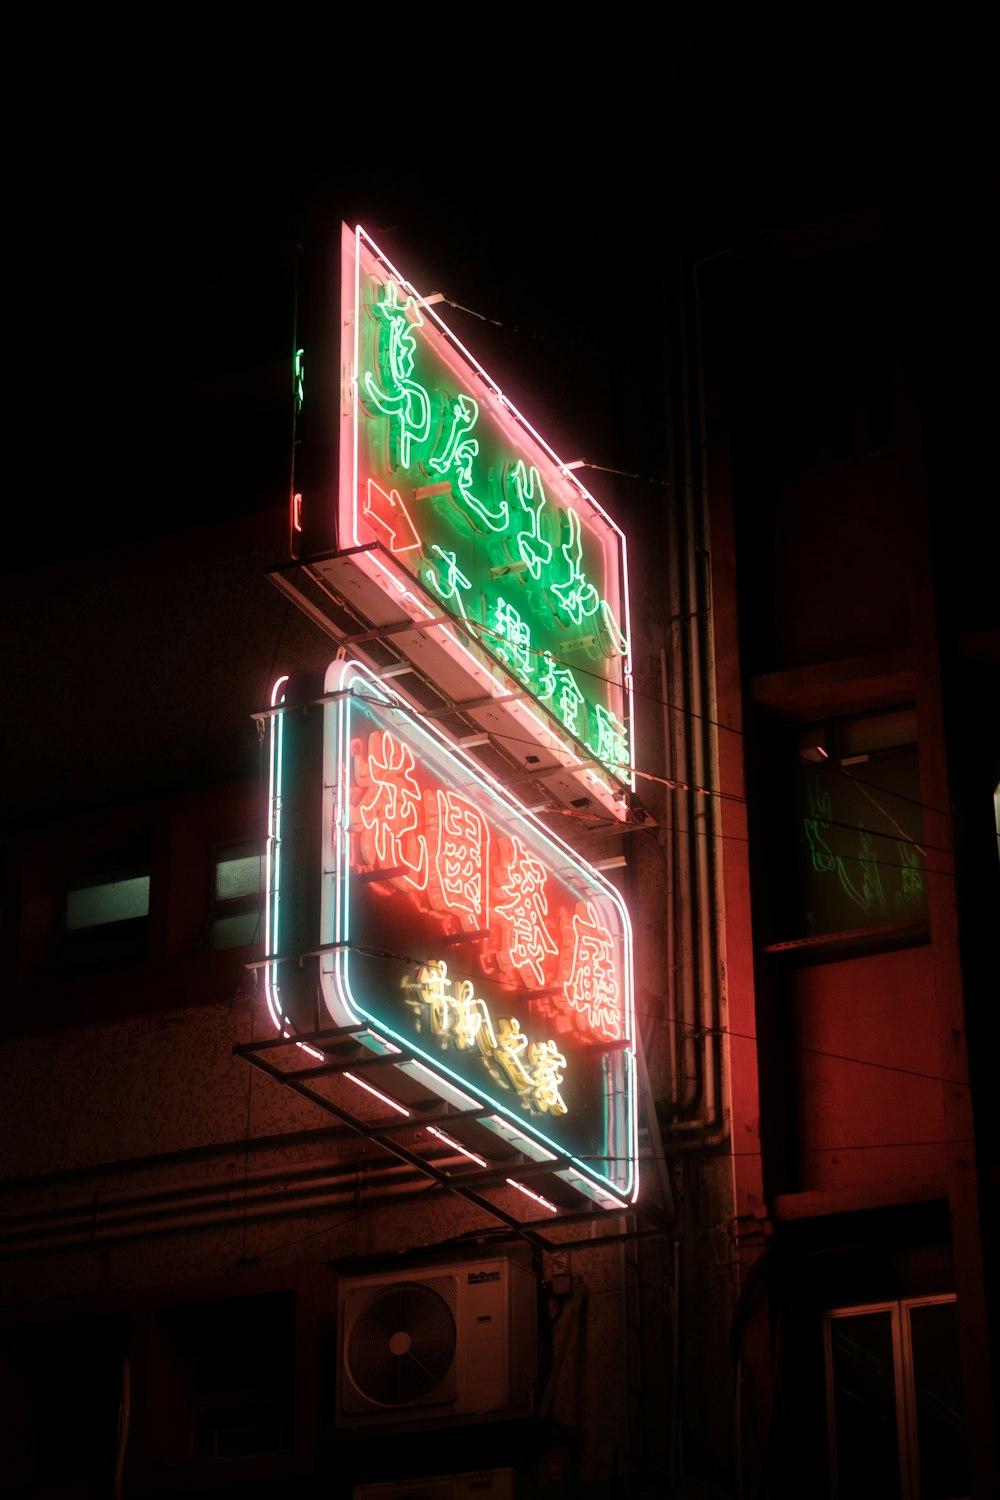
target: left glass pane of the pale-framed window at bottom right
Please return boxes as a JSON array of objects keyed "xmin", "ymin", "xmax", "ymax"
[{"xmin": 829, "ymin": 1311, "xmax": 901, "ymax": 1500}]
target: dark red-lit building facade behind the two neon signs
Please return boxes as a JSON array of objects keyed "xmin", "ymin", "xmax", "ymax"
[{"xmin": 0, "ymin": 29, "xmax": 1000, "ymax": 1500}]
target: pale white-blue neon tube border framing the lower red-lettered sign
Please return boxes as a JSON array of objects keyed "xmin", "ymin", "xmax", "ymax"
[{"xmin": 316, "ymin": 660, "xmax": 639, "ymax": 1206}]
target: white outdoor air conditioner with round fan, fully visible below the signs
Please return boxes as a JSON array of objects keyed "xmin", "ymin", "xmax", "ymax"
[{"xmin": 336, "ymin": 1259, "xmax": 538, "ymax": 1428}]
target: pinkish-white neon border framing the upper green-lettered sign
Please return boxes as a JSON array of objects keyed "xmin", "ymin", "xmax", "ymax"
[{"xmin": 337, "ymin": 225, "xmax": 636, "ymax": 818}]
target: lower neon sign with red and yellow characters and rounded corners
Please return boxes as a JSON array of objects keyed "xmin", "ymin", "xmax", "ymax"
[{"xmin": 265, "ymin": 660, "xmax": 637, "ymax": 1208}]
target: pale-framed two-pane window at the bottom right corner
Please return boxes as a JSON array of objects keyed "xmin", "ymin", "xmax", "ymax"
[{"xmin": 825, "ymin": 1296, "xmax": 969, "ymax": 1500}]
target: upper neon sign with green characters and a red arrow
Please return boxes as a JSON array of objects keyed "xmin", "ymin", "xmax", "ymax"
[{"xmin": 337, "ymin": 227, "xmax": 634, "ymax": 816}]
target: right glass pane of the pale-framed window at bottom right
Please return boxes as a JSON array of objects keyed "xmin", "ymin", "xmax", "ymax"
[{"xmin": 909, "ymin": 1302, "xmax": 969, "ymax": 1500}]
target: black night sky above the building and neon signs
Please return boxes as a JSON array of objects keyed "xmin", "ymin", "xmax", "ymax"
[{"xmin": 1, "ymin": 3, "xmax": 996, "ymax": 566}]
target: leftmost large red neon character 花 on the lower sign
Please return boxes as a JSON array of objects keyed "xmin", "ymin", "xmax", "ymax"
[{"xmin": 357, "ymin": 731, "xmax": 427, "ymax": 891}]
